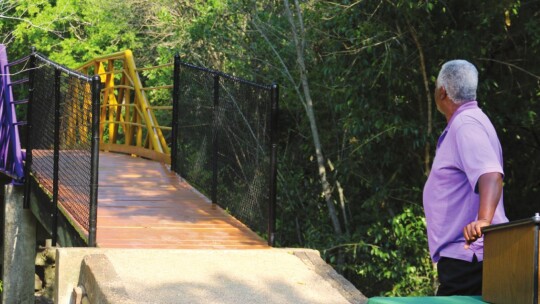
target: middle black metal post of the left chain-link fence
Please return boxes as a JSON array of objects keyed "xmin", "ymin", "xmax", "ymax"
[{"xmin": 52, "ymin": 68, "xmax": 62, "ymax": 246}]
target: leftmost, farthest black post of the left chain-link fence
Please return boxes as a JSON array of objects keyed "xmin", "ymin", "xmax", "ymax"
[{"xmin": 23, "ymin": 47, "xmax": 36, "ymax": 209}]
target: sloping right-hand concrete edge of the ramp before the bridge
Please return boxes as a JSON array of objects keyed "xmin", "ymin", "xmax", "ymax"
[{"xmin": 279, "ymin": 248, "xmax": 368, "ymax": 304}]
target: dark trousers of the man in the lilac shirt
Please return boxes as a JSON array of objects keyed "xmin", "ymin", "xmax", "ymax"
[{"xmin": 437, "ymin": 255, "xmax": 482, "ymax": 296}]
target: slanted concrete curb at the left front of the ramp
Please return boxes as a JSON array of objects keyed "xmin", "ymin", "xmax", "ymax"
[{"xmin": 79, "ymin": 254, "xmax": 135, "ymax": 304}]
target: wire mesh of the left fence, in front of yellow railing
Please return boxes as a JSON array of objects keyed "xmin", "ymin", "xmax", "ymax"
[{"xmin": 30, "ymin": 56, "xmax": 92, "ymax": 232}]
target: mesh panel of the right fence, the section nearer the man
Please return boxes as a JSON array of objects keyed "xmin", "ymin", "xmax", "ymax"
[{"xmin": 216, "ymin": 77, "xmax": 271, "ymax": 232}]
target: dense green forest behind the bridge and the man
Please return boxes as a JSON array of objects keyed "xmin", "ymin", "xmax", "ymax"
[{"xmin": 0, "ymin": 0, "xmax": 540, "ymax": 296}]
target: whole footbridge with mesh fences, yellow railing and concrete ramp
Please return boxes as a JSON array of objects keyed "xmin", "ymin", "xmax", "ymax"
[{"xmin": 0, "ymin": 45, "xmax": 367, "ymax": 304}]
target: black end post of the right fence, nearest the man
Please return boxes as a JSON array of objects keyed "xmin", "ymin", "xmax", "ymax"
[{"xmin": 268, "ymin": 84, "xmax": 279, "ymax": 246}]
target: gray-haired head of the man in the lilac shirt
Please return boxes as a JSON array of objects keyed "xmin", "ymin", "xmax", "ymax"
[{"xmin": 437, "ymin": 59, "xmax": 478, "ymax": 104}]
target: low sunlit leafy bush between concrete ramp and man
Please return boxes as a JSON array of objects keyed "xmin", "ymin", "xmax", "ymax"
[{"xmin": 343, "ymin": 208, "xmax": 435, "ymax": 296}]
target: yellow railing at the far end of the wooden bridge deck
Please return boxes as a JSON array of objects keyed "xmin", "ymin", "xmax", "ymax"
[{"xmin": 77, "ymin": 50, "xmax": 172, "ymax": 163}]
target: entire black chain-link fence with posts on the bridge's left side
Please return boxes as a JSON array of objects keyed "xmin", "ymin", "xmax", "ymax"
[{"xmin": 26, "ymin": 53, "xmax": 100, "ymax": 246}]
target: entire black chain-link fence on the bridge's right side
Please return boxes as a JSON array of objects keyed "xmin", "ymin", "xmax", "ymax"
[{"xmin": 171, "ymin": 56, "xmax": 278, "ymax": 245}]
